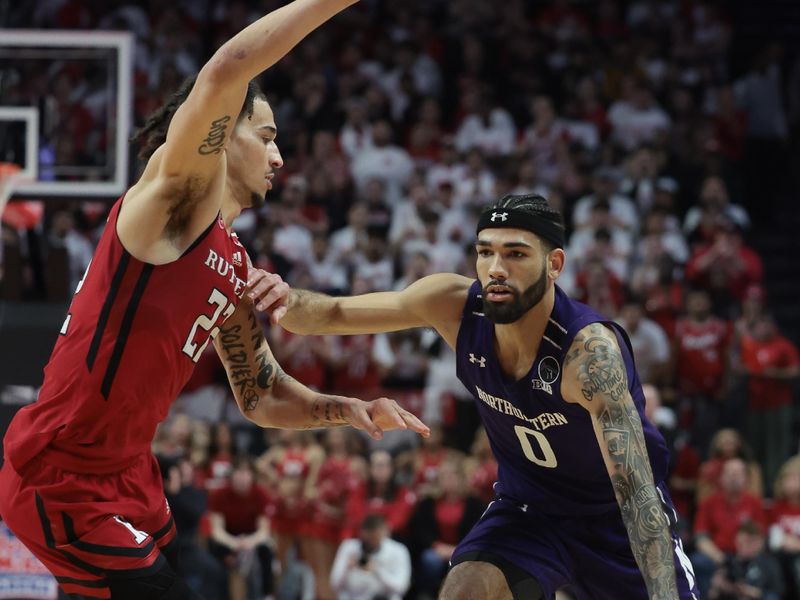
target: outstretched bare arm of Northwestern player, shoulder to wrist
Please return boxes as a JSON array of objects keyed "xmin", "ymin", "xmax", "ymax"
[{"xmin": 280, "ymin": 273, "xmax": 472, "ymax": 346}]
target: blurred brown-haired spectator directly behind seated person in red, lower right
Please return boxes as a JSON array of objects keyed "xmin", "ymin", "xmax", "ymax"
[{"xmin": 697, "ymin": 429, "xmax": 764, "ymax": 503}]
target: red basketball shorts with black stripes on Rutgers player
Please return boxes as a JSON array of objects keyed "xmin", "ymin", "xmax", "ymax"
[{"xmin": 0, "ymin": 454, "xmax": 175, "ymax": 598}]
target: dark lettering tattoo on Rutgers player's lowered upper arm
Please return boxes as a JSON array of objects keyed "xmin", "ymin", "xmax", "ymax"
[{"xmin": 219, "ymin": 312, "xmax": 282, "ymax": 412}]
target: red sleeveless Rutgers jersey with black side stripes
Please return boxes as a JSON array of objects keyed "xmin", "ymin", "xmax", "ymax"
[{"xmin": 4, "ymin": 199, "xmax": 247, "ymax": 473}]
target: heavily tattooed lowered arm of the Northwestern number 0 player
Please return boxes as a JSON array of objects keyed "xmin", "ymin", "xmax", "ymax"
[{"xmin": 561, "ymin": 323, "xmax": 678, "ymax": 600}]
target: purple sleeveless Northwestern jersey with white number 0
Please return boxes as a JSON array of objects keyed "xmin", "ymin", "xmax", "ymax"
[{"xmin": 456, "ymin": 281, "xmax": 669, "ymax": 516}]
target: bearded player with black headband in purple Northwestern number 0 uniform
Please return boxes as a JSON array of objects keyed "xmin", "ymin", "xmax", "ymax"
[{"xmin": 262, "ymin": 196, "xmax": 699, "ymax": 600}]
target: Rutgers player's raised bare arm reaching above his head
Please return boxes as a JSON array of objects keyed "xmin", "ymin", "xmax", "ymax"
[{"xmin": 119, "ymin": 0, "xmax": 356, "ymax": 248}]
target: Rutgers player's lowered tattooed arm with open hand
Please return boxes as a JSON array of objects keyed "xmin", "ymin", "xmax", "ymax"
[{"xmin": 209, "ymin": 302, "xmax": 430, "ymax": 439}]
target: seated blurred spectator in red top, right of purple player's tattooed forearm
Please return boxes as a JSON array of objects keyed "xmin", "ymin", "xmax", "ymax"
[{"xmin": 692, "ymin": 458, "xmax": 766, "ymax": 598}]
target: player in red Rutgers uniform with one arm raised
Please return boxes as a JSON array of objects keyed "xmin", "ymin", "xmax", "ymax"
[{"xmin": 0, "ymin": 0, "xmax": 427, "ymax": 600}]
